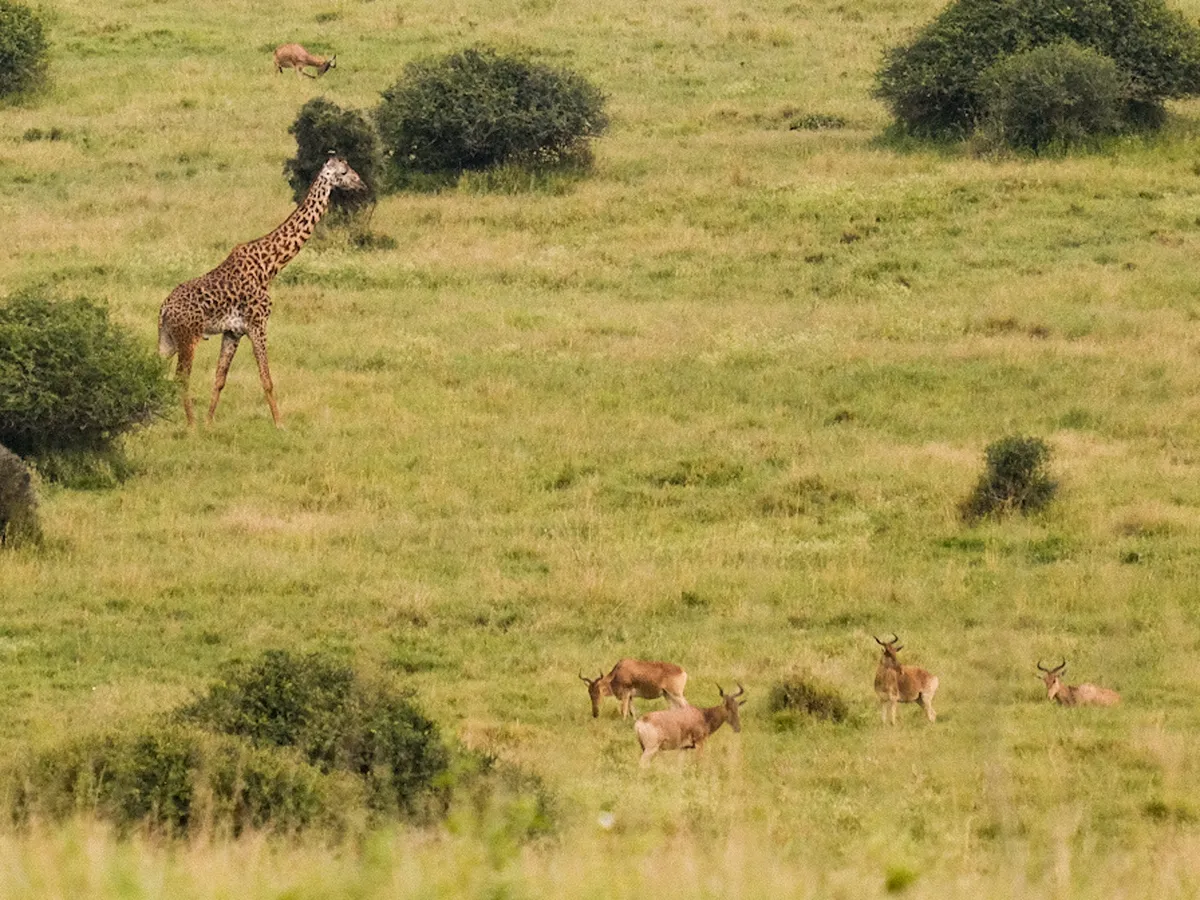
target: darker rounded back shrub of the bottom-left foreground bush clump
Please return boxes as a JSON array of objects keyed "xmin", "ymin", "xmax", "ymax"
[{"xmin": 181, "ymin": 650, "xmax": 450, "ymax": 815}]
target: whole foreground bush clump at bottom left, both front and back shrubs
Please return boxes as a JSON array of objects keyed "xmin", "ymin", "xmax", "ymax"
[{"xmin": 10, "ymin": 650, "xmax": 458, "ymax": 835}]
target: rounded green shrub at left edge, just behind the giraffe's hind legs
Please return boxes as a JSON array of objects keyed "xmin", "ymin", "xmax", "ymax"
[{"xmin": 0, "ymin": 292, "xmax": 176, "ymax": 474}]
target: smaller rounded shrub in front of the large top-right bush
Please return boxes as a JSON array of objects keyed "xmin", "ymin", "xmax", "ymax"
[{"xmin": 980, "ymin": 41, "xmax": 1129, "ymax": 151}]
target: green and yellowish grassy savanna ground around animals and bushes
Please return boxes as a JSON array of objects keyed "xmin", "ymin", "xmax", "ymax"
[{"xmin": 7, "ymin": 0, "xmax": 1200, "ymax": 900}]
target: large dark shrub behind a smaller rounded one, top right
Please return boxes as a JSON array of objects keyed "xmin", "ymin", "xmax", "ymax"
[{"xmin": 876, "ymin": 0, "xmax": 1200, "ymax": 136}]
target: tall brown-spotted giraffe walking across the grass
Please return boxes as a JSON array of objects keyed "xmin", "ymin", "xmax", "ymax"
[{"xmin": 158, "ymin": 156, "xmax": 366, "ymax": 427}]
